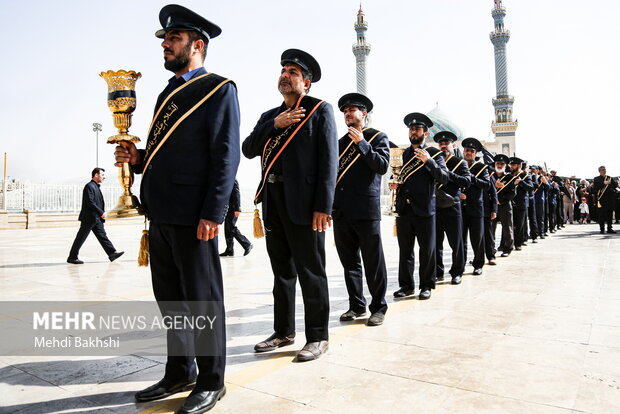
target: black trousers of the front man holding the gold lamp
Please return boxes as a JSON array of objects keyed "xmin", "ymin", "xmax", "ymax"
[{"xmin": 149, "ymin": 222, "xmax": 226, "ymax": 390}]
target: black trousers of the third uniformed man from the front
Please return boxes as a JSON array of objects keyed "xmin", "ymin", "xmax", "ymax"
[{"xmin": 334, "ymin": 217, "xmax": 387, "ymax": 314}]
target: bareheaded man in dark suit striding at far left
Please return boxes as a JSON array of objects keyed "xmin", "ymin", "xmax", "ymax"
[{"xmin": 67, "ymin": 168, "xmax": 125, "ymax": 264}]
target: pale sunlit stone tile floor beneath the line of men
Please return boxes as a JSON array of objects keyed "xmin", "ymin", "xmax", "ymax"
[{"xmin": 0, "ymin": 217, "xmax": 620, "ymax": 414}]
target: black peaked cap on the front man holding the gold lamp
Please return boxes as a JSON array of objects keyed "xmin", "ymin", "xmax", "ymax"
[{"xmin": 155, "ymin": 4, "xmax": 222, "ymax": 41}]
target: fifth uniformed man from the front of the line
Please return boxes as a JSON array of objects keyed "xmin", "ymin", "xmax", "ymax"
[{"xmin": 434, "ymin": 131, "xmax": 471, "ymax": 285}]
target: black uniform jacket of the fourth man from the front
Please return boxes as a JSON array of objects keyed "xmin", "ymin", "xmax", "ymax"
[{"xmin": 396, "ymin": 144, "xmax": 448, "ymax": 217}]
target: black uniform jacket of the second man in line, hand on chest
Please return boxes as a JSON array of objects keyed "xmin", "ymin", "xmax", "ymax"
[{"xmin": 242, "ymin": 95, "xmax": 338, "ymax": 225}]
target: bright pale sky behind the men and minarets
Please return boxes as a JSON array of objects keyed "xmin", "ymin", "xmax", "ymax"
[{"xmin": 0, "ymin": 0, "xmax": 620, "ymax": 189}]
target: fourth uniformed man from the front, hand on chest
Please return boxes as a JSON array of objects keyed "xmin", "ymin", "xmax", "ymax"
[{"xmin": 390, "ymin": 112, "xmax": 448, "ymax": 300}]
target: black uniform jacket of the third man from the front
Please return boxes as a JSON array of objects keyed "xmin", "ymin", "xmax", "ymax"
[{"xmin": 333, "ymin": 128, "xmax": 390, "ymax": 220}]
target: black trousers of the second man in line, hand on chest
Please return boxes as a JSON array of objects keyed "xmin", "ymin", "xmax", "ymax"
[{"xmin": 265, "ymin": 183, "xmax": 329, "ymax": 342}]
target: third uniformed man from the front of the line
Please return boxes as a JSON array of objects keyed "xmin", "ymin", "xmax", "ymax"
[{"xmin": 332, "ymin": 93, "xmax": 390, "ymax": 326}]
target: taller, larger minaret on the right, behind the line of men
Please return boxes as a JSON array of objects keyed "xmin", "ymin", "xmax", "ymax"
[{"xmin": 490, "ymin": 0, "xmax": 519, "ymax": 156}]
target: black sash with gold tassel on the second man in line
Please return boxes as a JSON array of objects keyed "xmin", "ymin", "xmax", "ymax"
[{"xmin": 254, "ymin": 95, "xmax": 323, "ymax": 239}]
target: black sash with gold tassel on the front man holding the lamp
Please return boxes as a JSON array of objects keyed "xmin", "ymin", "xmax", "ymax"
[{"xmin": 138, "ymin": 73, "xmax": 231, "ymax": 266}]
